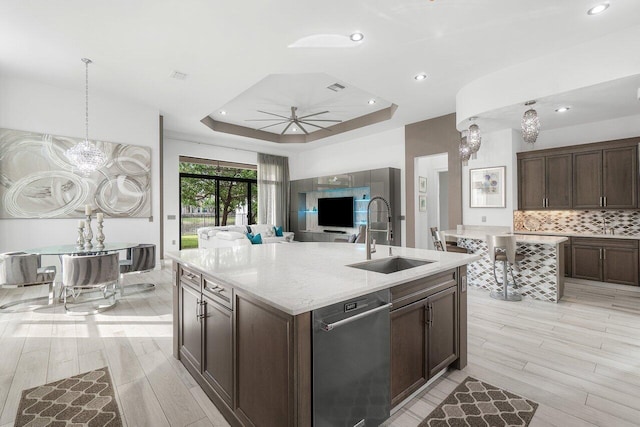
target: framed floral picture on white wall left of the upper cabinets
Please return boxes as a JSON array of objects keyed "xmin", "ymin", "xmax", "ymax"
[{"xmin": 469, "ymin": 166, "xmax": 506, "ymax": 208}]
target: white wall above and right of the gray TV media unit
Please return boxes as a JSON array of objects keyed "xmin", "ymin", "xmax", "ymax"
[{"xmin": 289, "ymin": 127, "xmax": 406, "ymax": 243}]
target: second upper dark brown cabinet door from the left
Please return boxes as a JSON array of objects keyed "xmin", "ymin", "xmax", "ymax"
[{"xmin": 545, "ymin": 154, "xmax": 573, "ymax": 209}]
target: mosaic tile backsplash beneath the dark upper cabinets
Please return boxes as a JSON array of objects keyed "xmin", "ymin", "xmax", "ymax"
[{"xmin": 513, "ymin": 209, "xmax": 640, "ymax": 236}]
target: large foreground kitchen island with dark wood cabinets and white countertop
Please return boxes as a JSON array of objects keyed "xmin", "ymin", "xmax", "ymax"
[{"xmin": 168, "ymin": 243, "xmax": 478, "ymax": 426}]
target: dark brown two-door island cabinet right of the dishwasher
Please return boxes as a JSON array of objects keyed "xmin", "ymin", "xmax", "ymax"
[{"xmin": 391, "ymin": 271, "xmax": 459, "ymax": 406}]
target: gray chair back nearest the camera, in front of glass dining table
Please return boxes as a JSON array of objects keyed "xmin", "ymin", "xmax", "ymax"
[{"xmin": 62, "ymin": 252, "xmax": 120, "ymax": 287}]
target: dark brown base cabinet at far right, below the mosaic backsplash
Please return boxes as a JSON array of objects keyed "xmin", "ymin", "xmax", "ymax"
[{"xmin": 572, "ymin": 237, "xmax": 638, "ymax": 286}]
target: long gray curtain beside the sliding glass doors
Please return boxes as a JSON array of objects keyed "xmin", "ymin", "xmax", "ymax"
[{"xmin": 258, "ymin": 153, "xmax": 289, "ymax": 231}]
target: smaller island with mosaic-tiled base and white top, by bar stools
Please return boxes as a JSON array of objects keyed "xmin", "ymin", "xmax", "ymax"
[{"xmin": 445, "ymin": 230, "xmax": 568, "ymax": 302}]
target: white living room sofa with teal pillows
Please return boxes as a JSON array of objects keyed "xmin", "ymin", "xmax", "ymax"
[{"xmin": 197, "ymin": 224, "xmax": 294, "ymax": 249}]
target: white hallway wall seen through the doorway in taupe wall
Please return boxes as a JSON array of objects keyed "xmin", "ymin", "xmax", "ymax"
[{"xmin": 414, "ymin": 153, "xmax": 449, "ymax": 249}]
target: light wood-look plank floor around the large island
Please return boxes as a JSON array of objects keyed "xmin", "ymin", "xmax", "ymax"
[{"xmin": 0, "ymin": 269, "xmax": 640, "ymax": 427}]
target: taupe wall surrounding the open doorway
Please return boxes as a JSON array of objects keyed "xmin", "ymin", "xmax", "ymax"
[{"xmin": 405, "ymin": 113, "xmax": 462, "ymax": 247}]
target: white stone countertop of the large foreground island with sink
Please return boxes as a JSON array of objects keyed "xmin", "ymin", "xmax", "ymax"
[{"xmin": 166, "ymin": 242, "xmax": 480, "ymax": 315}]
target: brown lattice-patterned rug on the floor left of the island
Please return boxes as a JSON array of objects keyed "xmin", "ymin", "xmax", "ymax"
[{"xmin": 15, "ymin": 366, "xmax": 122, "ymax": 427}]
